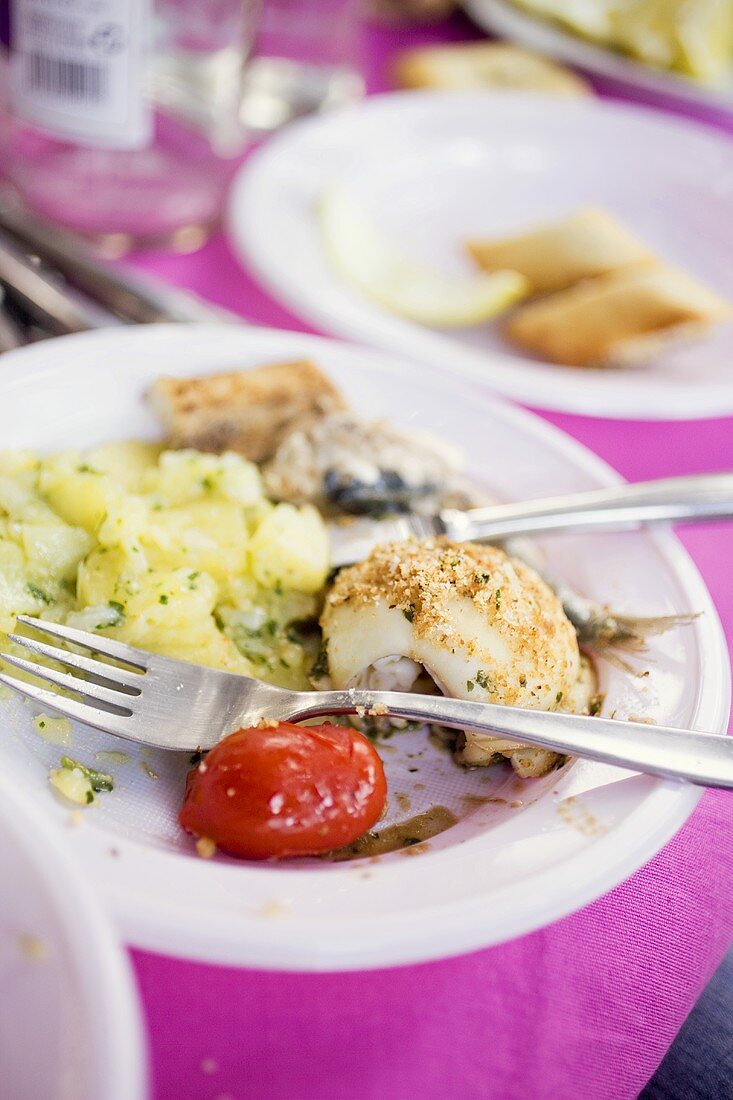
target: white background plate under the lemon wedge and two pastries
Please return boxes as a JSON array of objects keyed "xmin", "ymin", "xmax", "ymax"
[{"xmin": 229, "ymin": 92, "xmax": 733, "ymax": 419}]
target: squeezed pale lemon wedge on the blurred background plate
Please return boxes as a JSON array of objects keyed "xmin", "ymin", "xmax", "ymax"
[{"xmin": 318, "ymin": 187, "xmax": 529, "ymax": 328}]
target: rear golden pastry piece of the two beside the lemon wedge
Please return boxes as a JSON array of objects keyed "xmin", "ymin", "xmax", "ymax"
[{"xmin": 467, "ymin": 207, "xmax": 654, "ymax": 294}]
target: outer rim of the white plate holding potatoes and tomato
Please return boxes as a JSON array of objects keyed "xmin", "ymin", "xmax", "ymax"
[{"xmin": 0, "ymin": 325, "xmax": 730, "ymax": 971}]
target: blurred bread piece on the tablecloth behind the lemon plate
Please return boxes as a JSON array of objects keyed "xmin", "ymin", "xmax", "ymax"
[{"xmin": 393, "ymin": 42, "xmax": 592, "ymax": 96}]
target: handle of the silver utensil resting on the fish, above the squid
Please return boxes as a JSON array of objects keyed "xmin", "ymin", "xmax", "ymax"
[{"xmin": 440, "ymin": 473, "xmax": 733, "ymax": 541}]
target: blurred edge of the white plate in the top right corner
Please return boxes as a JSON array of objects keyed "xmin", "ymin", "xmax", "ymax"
[{"xmin": 463, "ymin": 0, "xmax": 733, "ymax": 113}]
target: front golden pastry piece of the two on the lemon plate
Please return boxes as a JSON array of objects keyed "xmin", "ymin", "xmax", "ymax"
[{"xmin": 504, "ymin": 263, "xmax": 733, "ymax": 366}]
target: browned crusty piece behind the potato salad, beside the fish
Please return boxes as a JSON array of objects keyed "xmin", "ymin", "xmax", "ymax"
[{"xmin": 150, "ymin": 360, "xmax": 346, "ymax": 462}]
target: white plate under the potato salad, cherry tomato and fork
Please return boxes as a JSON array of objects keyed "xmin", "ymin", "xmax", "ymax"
[{"xmin": 0, "ymin": 326, "xmax": 729, "ymax": 969}]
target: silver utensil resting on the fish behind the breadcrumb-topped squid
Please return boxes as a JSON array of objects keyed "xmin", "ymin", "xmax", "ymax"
[{"xmin": 329, "ymin": 473, "xmax": 733, "ymax": 568}]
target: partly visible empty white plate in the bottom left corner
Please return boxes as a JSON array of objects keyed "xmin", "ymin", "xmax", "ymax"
[{"xmin": 0, "ymin": 768, "xmax": 146, "ymax": 1100}]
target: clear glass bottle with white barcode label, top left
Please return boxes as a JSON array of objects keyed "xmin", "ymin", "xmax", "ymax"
[{"xmin": 4, "ymin": 0, "xmax": 261, "ymax": 254}]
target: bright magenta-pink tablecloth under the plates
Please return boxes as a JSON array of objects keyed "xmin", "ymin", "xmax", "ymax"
[{"xmin": 128, "ymin": 21, "xmax": 733, "ymax": 1100}]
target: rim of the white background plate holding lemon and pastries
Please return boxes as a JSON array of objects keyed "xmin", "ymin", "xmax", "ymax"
[{"xmin": 231, "ymin": 89, "xmax": 733, "ymax": 422}]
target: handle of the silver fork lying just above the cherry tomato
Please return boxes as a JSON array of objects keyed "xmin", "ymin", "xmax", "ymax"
[{"xmin": 278, "ymin": 690, "xmax": 733, "ymax": 789}]
